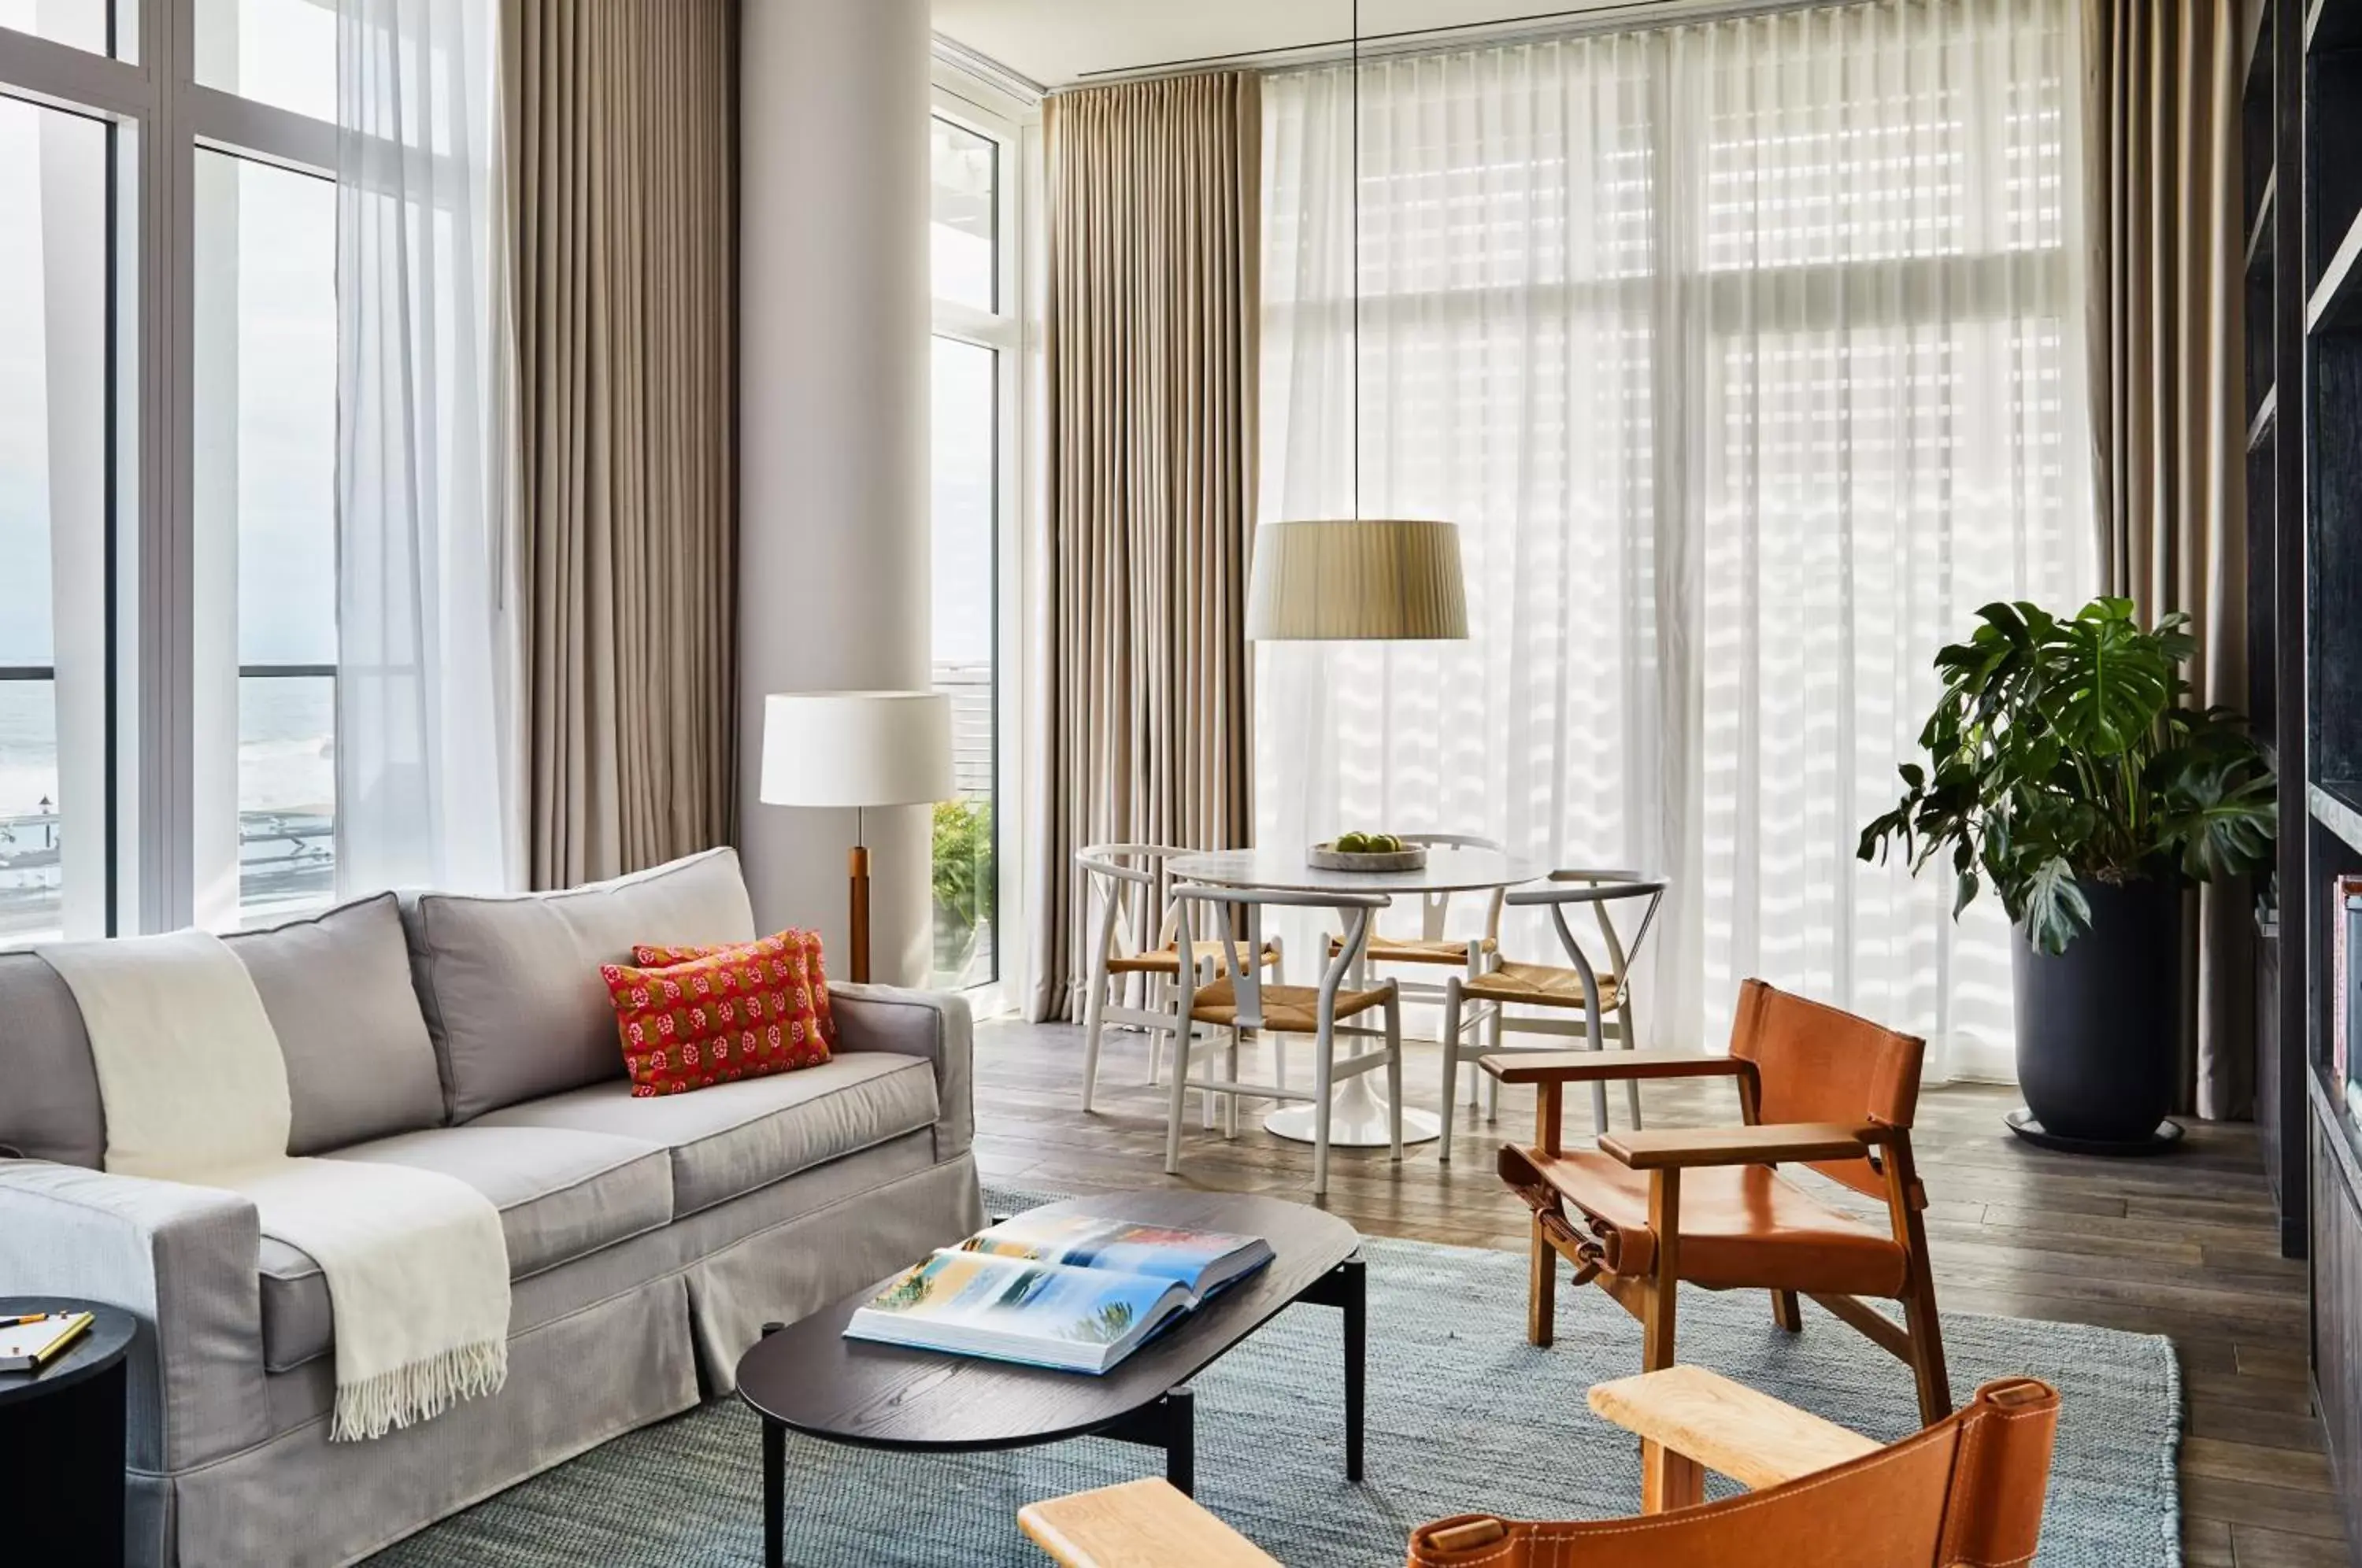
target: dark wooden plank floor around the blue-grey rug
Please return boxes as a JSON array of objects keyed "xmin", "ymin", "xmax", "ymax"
[{"xmin": 976, "ymin": 1023, "xmax": 2348, "ymax": 1568}]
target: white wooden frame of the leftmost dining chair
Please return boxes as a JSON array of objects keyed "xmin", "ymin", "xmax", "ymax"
[{"xmin": 1075, "ymin": 843, "xmax": 1287, "ymax": 1124}]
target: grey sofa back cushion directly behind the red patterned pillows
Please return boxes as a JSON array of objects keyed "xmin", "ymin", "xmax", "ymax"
[{"xmin": 402, "ymin": 850, "xmax": 756, "ymax": 1122}]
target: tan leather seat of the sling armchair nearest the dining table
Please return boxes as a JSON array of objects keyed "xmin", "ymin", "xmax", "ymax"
[{"xmin": 1500, "ymin": 1148, "xmax": 1908, "ymax": 1296}]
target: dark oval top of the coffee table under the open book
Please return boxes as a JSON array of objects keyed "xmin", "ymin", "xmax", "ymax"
[{"xmin": 737, "ymin": 1190, "xmax": 1361, "ymax": 1450}]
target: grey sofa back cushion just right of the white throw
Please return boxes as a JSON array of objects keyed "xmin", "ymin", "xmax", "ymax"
[{"xmin": 222, "ymin": 893, "xmax": 444, "ymax": 1155}]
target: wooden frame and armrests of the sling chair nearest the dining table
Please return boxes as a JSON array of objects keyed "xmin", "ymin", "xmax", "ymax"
[{"xmin": 1481, "ymin": 980, "xmax": 1951, "ymax": 1424}]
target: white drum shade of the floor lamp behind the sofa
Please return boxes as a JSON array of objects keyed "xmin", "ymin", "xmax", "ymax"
[{"xmin": 763, "ymin": 692, "xmax": 959, "ymax": 805}]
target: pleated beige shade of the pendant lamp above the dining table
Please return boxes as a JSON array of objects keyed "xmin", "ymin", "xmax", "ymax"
[{"xmin": 1247, "ymin": 517, "xmax": 1469, "ymax": 642}]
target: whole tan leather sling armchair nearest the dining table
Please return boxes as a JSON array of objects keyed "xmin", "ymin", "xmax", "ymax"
[{"xmin": 1481, "ymin": 980, "xmax": 1951, "ymax": 1424}]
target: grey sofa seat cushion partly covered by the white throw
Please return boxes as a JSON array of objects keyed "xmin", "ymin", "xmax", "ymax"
[{"xmin": 260, "ymin": 1126, "xmax": 673, "ymax": 1372}]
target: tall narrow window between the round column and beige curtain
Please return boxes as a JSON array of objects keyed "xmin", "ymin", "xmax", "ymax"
[{"xmin": 931, "ymin": 116, "xmax": 1016, "ymax": 987}]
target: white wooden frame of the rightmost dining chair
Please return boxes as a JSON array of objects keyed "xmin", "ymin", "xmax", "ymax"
[{"xmin": 1436, "ymin": 867, "xmax": 1668, "ymax": 1164}]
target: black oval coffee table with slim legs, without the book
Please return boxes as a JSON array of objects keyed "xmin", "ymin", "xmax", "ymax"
[{"xmin": 737, "ymin": 1193, "xmax": 1365, "ymax": 1568}]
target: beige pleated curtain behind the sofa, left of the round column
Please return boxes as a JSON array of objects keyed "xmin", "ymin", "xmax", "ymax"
[{"xmin": 508, "ymin": 0, "xmax": 737, "ymax": 888}]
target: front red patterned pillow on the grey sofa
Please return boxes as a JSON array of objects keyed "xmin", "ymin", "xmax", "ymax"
[{"xmin": 600, "ymin": 935, "xmax": 829, "ymax": 1098}]
